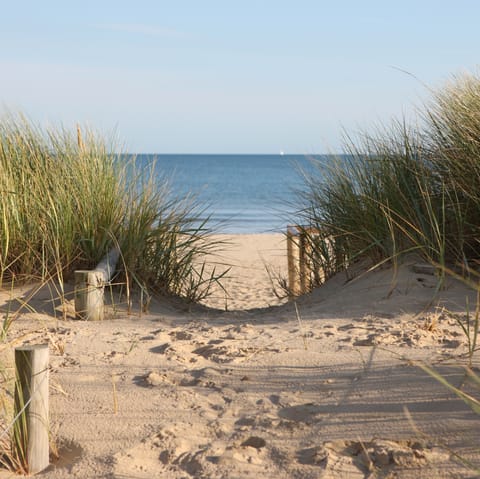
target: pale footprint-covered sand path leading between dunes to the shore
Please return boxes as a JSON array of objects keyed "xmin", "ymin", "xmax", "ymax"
[{"xmin": 0, "ymin": 235, "xmax": 480, "ymax": 479}]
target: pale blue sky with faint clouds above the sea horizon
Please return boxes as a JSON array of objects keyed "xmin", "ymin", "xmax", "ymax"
[{"xmin": 0, "ymin": 0, "xmax": 480, "ymax": 154}]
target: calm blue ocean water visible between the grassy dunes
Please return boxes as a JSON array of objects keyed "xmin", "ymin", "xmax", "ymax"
[{"xmin": 137, "ymin": 155, "xmax": 328, "ymax": 233}]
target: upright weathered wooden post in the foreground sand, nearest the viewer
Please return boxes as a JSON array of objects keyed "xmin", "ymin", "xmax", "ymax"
[{"xmin": 13, "ymin": 344, "xmax": 50, "ymax": 474}]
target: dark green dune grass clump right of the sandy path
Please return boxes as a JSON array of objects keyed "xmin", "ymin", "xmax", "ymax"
[{"xmin": 300, "ymin": 71, "xmax": 480, "ymax": 282}]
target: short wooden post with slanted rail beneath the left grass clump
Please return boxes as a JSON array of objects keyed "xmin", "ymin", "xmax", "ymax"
[{"xmin": 75, "ymin": 248, "xmax": 120, "ymax": 321}]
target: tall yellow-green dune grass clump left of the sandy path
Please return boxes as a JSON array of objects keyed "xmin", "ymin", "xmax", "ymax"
[{"xmin": 0, "ymin": 115, "xmax": 225, "ymax": 301}]
